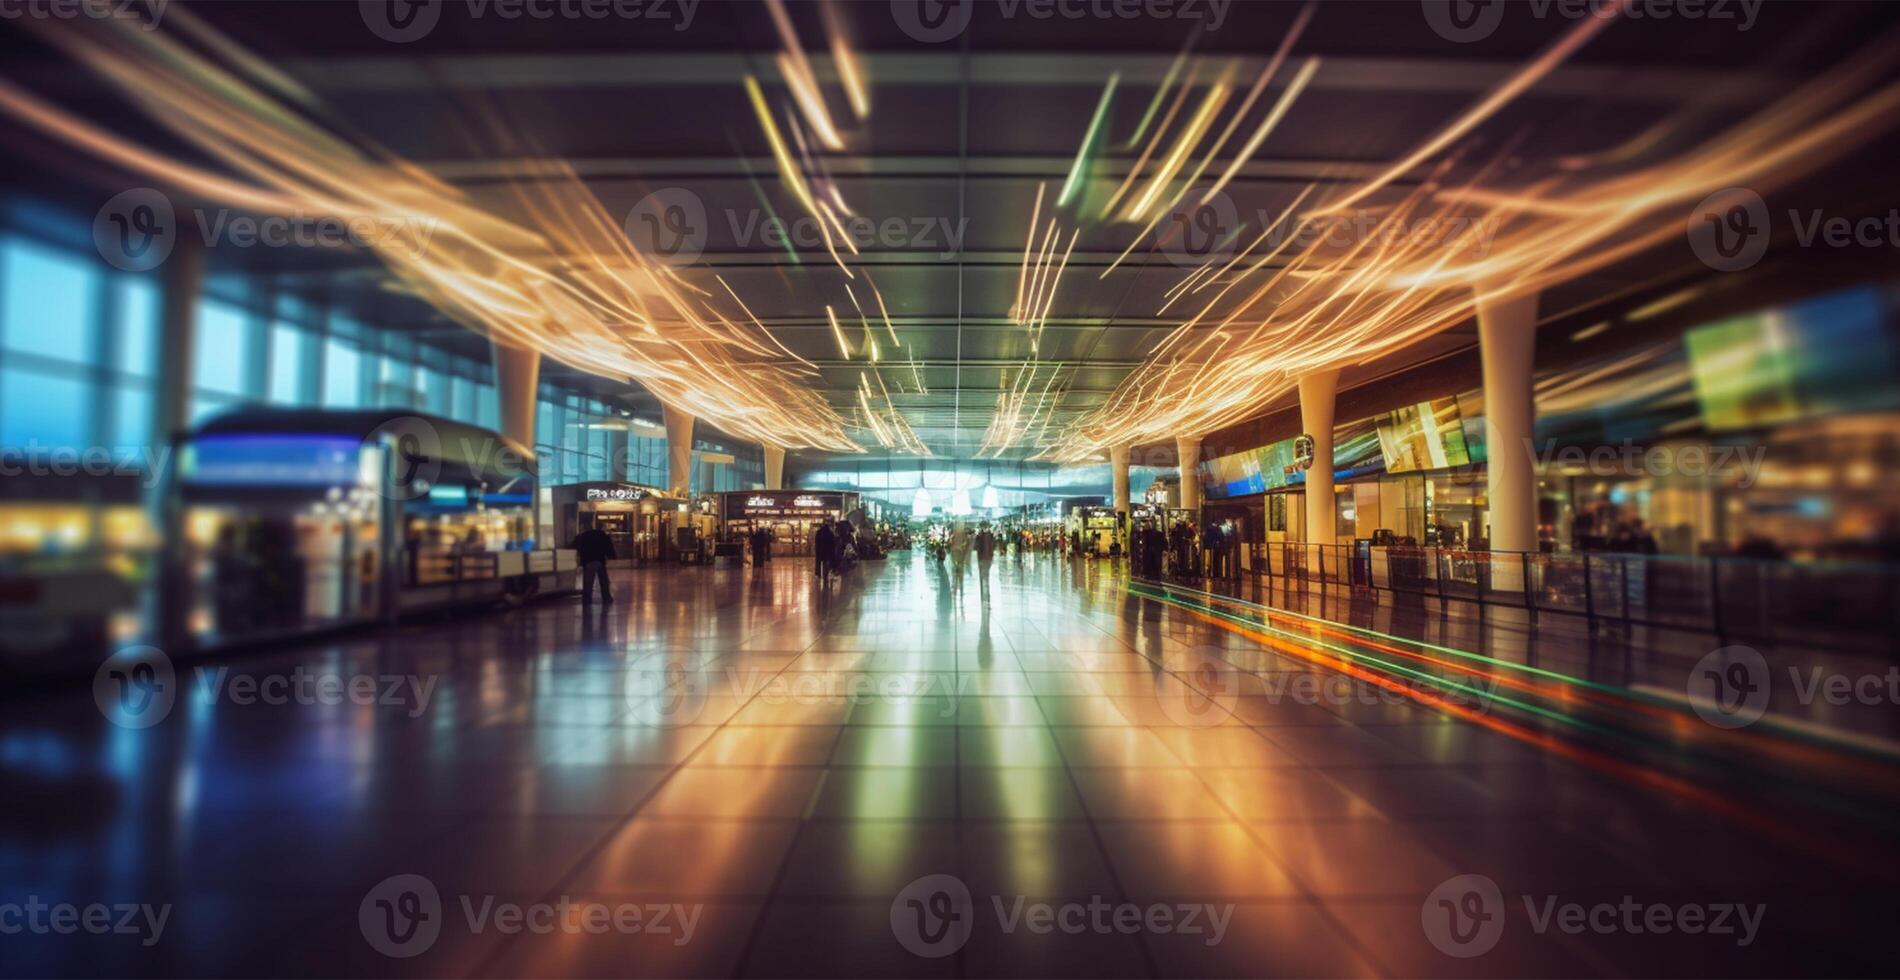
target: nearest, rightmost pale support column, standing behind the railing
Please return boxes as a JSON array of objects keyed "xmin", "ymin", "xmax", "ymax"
[{"xmin": 1478, "ymin": 291, "xmax": 1537, "ymax": 551}]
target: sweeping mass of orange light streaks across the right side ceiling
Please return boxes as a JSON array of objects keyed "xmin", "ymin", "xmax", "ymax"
[{"xmin": 1039, "ymin": 21, "xmax": 1900, "ymax": 462}]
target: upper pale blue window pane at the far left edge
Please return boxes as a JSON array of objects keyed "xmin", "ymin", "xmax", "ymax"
[{"xmin": 0, "ymin": 239, "xmax": 101, "ymax": 363}]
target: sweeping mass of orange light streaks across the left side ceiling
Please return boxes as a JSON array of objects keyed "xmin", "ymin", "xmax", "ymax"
[{"xmin": 0, "ymin": 9, "xmax": 861, "ymax": 452}]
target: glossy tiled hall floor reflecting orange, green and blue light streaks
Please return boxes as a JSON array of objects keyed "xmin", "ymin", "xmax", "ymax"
[{"xmin": 0, "ymin": 555, "xmax": 1896, "ymax": 976}]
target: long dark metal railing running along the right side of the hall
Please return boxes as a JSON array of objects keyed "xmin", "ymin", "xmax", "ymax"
[{"xmin": 1140, "ymin": 541, "xmax": 1900, "ymax": 657}]
